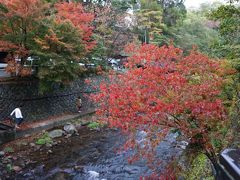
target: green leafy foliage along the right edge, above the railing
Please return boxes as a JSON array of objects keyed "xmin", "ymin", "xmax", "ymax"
[{"xmin": 210, "ymin": 0, "xmax": 240, "ymax": 145}]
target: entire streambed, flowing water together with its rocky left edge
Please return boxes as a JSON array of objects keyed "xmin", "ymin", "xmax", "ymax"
[{"xmin": 0, "ymin": 119, "xmax": 186, "ymax": 180}]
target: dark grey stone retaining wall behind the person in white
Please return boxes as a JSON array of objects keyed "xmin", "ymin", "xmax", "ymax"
[{"xmin": 0, "ymin": 76, "xmax": 102, "ymax": 121}]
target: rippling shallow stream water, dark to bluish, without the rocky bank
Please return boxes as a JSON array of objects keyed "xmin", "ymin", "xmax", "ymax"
[{"xmin": 16, "ymin": 128, "xmax": 182, "ymax": 180}]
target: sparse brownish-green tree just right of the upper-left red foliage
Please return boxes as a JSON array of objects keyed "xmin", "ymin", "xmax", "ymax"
[{"xmin": 85, "ymin": 0, "xmax": 134, "ymax": 62}]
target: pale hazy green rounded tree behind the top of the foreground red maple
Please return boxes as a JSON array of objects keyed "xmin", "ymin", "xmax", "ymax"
[{"xmin": 173, "ymin": 9, "xmax": 220, "ymax": 55}]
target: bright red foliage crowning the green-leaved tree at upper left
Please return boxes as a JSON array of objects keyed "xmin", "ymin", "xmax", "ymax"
[{"xmin": 55, "ymin": 2, "xmax": 96, "ymax": 51}]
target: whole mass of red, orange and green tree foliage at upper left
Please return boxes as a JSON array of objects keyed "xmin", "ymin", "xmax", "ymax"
[{"xmin": 0, "ymin": 0, "xmax": 95, "ymax": 82}]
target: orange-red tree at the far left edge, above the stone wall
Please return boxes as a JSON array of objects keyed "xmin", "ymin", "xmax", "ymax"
[{"xmin": 0, "ymin": 0, "xmax": 48, "ymax": 76}]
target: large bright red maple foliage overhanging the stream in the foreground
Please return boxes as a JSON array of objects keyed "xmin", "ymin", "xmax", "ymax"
[{"xmin": 93, "ymin": 45, "xmax": 227, "ymax": 172}]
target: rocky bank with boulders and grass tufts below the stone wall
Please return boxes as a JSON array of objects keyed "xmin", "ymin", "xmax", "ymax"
[{"xmin": 0, "ymin": 116, "xmax": 98, "ymax": 179}]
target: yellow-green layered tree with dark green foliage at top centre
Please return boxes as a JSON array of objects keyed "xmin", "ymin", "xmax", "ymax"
[{"xmin": 133, "ymin": 0, "xmax": 186, "ymax": 45}]
